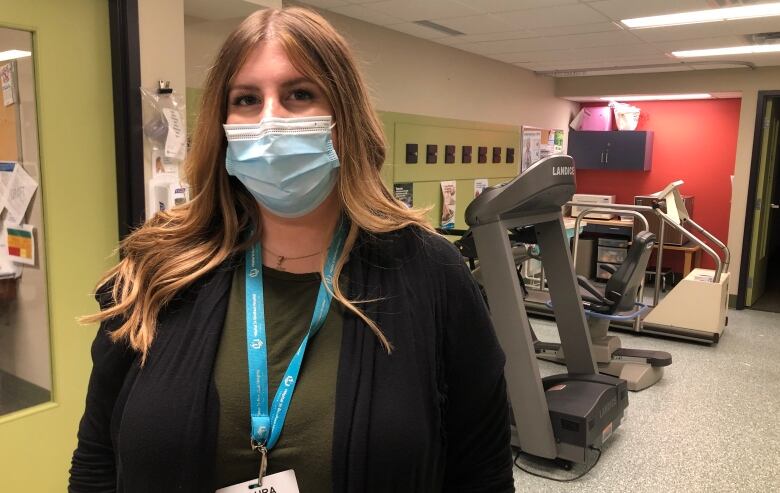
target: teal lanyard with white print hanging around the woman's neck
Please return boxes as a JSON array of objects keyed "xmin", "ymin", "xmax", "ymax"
[{"xmin": 245, "ymin": 219, "xmax": 347, "ymax": 450}]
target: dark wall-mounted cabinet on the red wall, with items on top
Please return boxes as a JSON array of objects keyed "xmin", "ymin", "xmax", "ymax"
[{"xmin": 568, "ymin": 130, "xmax": 653, "ymax": 171}]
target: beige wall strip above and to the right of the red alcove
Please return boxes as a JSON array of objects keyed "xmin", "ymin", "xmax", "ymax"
[{"xmin": 555, "ymin": 67, "xmax": 780, "ymax": 294}]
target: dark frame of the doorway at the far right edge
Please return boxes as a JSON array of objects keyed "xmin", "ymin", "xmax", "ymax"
[{"xmin": 736, "ymin": 91, "xmax": 780, "ymax": 310}]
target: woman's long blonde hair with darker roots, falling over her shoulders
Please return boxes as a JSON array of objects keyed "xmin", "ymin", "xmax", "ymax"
[{"xmin": 82, "ymin": 8, "xmax": 431, "ymax": 360}]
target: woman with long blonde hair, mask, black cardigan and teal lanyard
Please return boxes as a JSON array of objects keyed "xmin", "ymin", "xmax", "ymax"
[{"xmin": 70, "ymin": 8, "xmax": 513, "ymax": 493}]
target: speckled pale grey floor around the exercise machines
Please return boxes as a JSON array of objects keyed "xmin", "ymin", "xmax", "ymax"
[{"xmin": 514, "ymin": 310, "xmax": 780, "ymax": 493}]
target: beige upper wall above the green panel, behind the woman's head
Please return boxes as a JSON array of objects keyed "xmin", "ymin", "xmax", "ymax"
[{"xmin": 185, "ymin": 12, "xmax": 575, "ymax": 132}]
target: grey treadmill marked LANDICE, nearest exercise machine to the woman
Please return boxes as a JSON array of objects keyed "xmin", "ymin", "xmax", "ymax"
[{"xmin": 466, "ymin": 155, "xmax": 628, "ymax": 463}]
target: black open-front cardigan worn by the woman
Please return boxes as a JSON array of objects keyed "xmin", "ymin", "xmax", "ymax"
[{"xmin": 69, "ymin": 227, "xmax": 514, "ymax": 493}]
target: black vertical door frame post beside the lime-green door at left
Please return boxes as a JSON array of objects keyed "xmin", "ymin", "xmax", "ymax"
[{"xmin": 108, "ymin": 0, "xmax": 145, "ymax": 239}]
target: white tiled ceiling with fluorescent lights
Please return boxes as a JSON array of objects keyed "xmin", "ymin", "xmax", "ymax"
[{"xmin": 185, "ymin": 0, "xmax": 780, "ymax": 76}]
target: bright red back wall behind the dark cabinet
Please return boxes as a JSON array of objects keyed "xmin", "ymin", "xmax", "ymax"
[{"xmin": 577, "ymin": 99, "xmax": 741, "ymax": 270}]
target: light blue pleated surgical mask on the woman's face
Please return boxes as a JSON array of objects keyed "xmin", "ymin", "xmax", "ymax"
[{"xmin": 224, "ymin": 116, "xmax": 339, "ymax": 217}]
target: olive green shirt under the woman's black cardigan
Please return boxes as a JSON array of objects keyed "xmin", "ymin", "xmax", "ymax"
[{"xmin": 214, "ymin": 264, "xmax": 344, "ymax": 493}]
